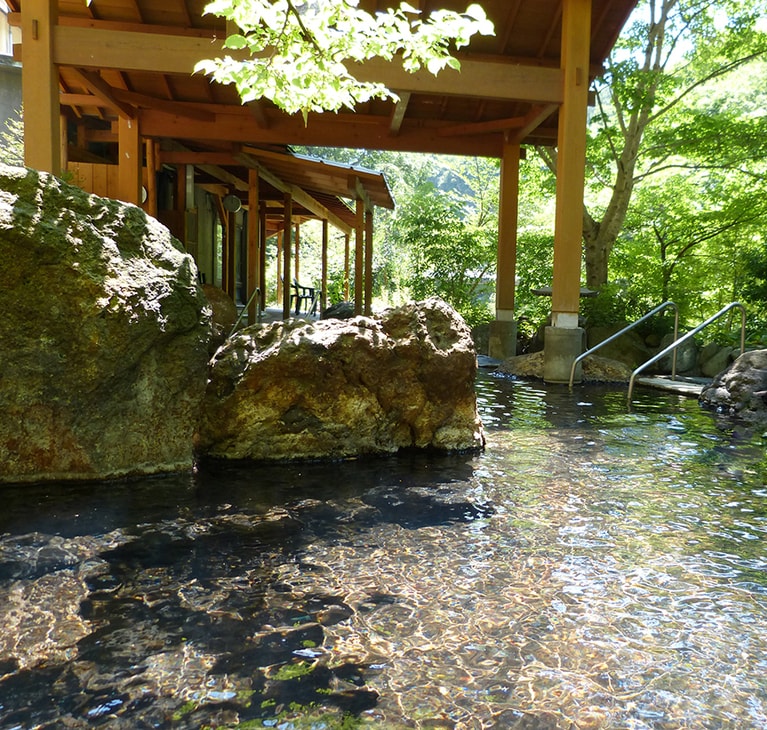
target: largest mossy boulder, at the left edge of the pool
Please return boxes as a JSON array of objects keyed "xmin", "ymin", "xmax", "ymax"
[{"xmin": 0, "ymin": 165, "xmax": 210, "ymax": 482}]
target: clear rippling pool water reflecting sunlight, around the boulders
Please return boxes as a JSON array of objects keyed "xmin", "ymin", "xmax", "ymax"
[{"xmin": 0, "ymin": 375, "xmax": 767, "ymax": 729}]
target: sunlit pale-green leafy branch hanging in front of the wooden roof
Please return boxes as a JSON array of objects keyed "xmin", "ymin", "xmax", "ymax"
[{"xmin": 196, "ymin": 0, "xmax": 493, "ymax": 120}]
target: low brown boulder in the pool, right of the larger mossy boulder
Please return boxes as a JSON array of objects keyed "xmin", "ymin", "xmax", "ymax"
[{"xmin": 198, "ymin": 299, "xmax": 484, "ymax": 460}]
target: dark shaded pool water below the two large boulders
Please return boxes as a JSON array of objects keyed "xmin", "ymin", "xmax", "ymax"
[{"xmin": 0, "ymin": 454, "xmax": 492, "ymax": 728}]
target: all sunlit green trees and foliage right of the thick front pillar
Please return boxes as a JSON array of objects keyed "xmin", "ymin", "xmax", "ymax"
[{"xmin": 528, "ymin": 0, "xmax": 767, "ymax": 340}]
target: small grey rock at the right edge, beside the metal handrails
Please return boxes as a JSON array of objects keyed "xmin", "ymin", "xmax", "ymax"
[{"xmin": 700, "ymin": 350, "xmax": 767, "ymax": 423}]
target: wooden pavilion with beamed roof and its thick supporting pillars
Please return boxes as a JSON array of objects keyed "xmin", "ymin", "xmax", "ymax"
[{"xmin": 9, "ymin": 0, "xmax": 636, "ymax": 382}]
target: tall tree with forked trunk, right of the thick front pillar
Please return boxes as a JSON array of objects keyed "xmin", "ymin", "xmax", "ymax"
[{"xmin": 546, "ymin": 0, "xmax": 767, "ymax": 296}]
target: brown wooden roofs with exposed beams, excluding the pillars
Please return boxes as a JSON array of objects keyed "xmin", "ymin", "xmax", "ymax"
[{"xmin": 8, "ymin": 0, "xmax": 637, "ymax": 224}]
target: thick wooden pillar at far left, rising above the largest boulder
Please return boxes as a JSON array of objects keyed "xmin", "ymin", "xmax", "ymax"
[{"xmin": 21, "ymin": 0, "xmax": 62, "ymax": 175}]
